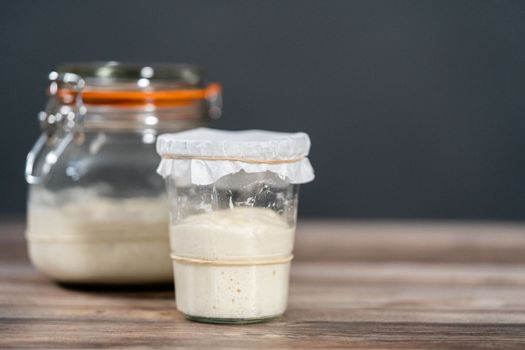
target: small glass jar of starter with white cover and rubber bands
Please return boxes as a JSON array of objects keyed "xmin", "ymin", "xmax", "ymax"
[{"xmin": 157, "ymin": 129, "xmax": 313, "ymax": 323}]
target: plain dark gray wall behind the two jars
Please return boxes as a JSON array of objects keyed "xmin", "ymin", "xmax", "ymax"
[{"xmin": 0, "ymin": 0, "xmax": 525, "ymax": 220}]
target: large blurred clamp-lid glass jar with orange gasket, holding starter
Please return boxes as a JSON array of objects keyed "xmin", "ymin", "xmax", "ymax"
[{"xmin": 26, "ymin": 62, "xmax": 221, "ymax": 284}]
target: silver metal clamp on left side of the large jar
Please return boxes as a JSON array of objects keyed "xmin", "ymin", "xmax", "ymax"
[{"xmin": 25, "ymin": 72, "xmax": 86, "ymax": 184}]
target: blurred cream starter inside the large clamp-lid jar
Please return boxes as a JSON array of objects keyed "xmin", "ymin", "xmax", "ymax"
[{"xmin": 27, "ymin": 189, "xmax": 173, "ymax": 283}]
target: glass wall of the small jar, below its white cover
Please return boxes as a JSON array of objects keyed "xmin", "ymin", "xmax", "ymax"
[{"xmin": 167, "ymin": 171, "xmax": 299, "ymax": 323}]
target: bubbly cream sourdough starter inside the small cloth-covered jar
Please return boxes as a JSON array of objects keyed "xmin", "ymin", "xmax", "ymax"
[{"xmin": 170, "ymin": 208, "xmax": 295, "ymax": 319}]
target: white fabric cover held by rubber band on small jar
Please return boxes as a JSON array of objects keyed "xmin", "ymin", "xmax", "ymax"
[{"xmin": 157, "ymin": 128, "xmax": 314, "ymax": 185}]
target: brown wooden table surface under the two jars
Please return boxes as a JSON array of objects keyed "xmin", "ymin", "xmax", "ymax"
[{"xmin": 0, "ymin": 219, "xmax": 525, "ymax": 349}]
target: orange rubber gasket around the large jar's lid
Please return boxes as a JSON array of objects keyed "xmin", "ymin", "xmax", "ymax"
[{"xmin": 57, "ymin": 83, "xmax": 222, "ymax": 107}]
